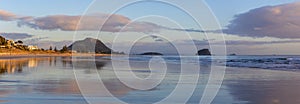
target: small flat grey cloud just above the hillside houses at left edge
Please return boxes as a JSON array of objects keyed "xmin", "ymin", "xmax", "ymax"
[{"xmin": 0, "ymin": 33, "xmax": 33, "ymax": 40}]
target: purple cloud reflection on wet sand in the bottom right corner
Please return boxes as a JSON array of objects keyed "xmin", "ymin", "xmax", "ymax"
[{"xmin": 224, "ymin": 69, "xmax": 300, "ymax": 104}]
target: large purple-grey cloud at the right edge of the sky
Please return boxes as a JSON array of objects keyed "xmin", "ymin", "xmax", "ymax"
[{"xmin": 223, "ymin": 2, "xmax": 300, "ymax": 38}]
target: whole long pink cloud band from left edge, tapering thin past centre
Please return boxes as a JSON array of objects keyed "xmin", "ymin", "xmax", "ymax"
[{"xmin": 0, "ymin": 10, "xmax": 203, "ymax": 33}]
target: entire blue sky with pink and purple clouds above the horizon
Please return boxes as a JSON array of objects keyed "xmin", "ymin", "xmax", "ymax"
[{"xmin": 0, "ymin": 0, "xmax": 300, "ymax": 55}]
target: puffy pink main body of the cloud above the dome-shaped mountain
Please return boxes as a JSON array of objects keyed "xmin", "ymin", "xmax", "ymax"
[{"xmin": 18, "ymin": 14, "xmax": 134, "ymax": 32}]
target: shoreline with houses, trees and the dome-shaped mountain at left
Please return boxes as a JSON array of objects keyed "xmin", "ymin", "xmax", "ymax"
[{"xmin": 0, "ymin": 36, "xmax": 115, "ymax": 56}]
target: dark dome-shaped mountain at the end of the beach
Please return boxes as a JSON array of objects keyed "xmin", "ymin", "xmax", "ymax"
[{"xmin": 68, "ymin": 38, "xmax": 112, "ymax": 54}]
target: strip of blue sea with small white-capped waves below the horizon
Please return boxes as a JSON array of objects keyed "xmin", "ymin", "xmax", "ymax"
[{"xmin": 102, "ymin": 56, "xmax": 300, "ymax": 71}]
